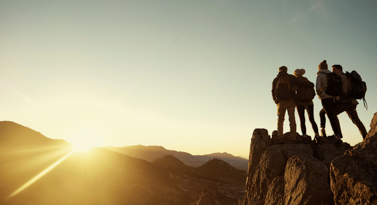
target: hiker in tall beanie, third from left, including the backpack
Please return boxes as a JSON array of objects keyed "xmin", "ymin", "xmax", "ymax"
[{"xmin": 316, "ymin": 60, "xmax": 343, "ymax": 139}]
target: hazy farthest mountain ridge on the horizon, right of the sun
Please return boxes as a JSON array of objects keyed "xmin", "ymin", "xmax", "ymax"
[{"xmin": 106, "ymin": 145, "xmax": 248, "ymax": 171}]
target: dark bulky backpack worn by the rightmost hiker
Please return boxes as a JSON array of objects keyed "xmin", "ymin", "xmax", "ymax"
[{"xmin": 346, "ymin": 70, "xmax": 368, "ymax": 108}]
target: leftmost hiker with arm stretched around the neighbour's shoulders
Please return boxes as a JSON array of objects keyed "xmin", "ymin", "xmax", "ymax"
[{"xmin": 271, "ymin": 66, "xmax": 314, "ymax": 143}]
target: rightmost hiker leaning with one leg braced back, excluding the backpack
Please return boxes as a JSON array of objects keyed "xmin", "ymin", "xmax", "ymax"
[{"xmin": 320, "ymin": 65, "xmax": 367, "ymax": 139}]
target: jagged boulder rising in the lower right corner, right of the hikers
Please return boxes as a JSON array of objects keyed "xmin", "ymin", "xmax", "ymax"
[{"xmin": 330, "ymin": 113, "xmax": 377, "ymax": 204}]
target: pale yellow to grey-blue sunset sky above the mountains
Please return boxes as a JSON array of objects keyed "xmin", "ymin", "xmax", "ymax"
[{"xmin": 0, "ymin": 0, "xmax": 377, "ymax": 157}]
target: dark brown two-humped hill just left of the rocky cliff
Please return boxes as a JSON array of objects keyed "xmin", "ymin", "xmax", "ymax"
[{"xmin": 152, "ymin": 155, "xmax": 246, "ymax": 204}]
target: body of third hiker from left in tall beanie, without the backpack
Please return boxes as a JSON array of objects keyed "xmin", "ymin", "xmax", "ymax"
[{"xmin": 316, "ymin": 60, "xmax": 343, "ymax": 139}]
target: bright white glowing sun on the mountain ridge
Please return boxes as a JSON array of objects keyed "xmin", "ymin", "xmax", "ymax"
[{"xmin": 67, "ymin": 129, "xmax": 104, "ymax": 152}]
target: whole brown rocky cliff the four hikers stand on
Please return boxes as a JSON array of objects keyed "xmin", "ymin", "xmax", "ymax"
[{"xmin": 243, "ymin": 113, "xmax": 377, "ymax": 205}]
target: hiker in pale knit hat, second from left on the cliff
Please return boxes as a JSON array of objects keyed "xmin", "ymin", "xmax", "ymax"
[{"xmin": 293, "ymin": 69, "xmax": 319, "ymax": 139}]
